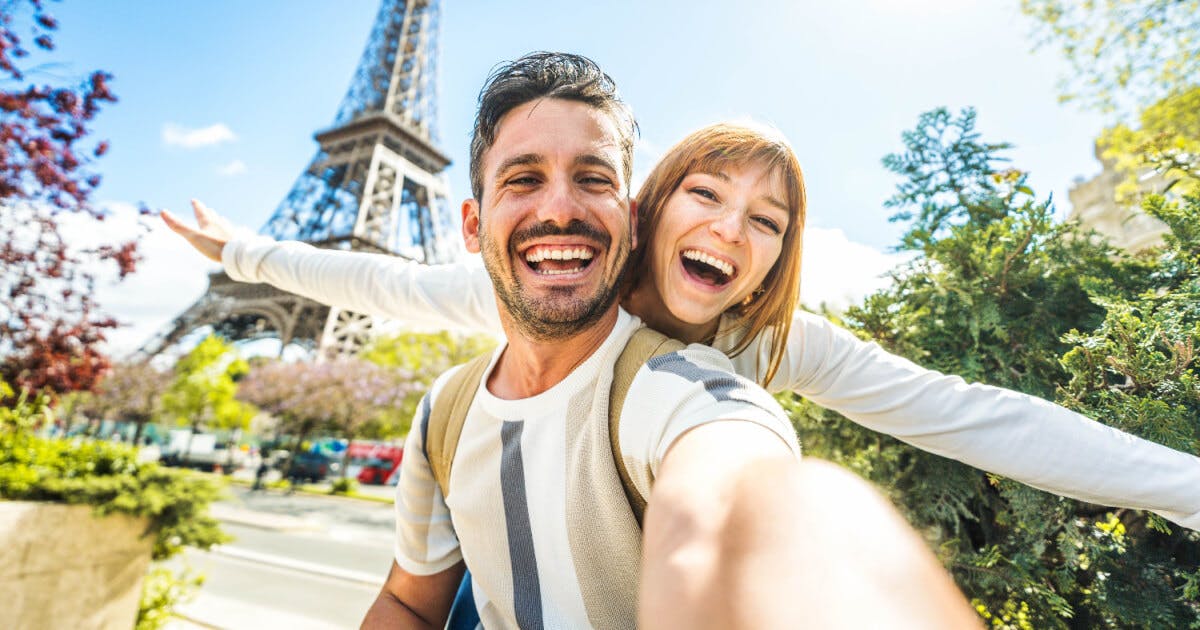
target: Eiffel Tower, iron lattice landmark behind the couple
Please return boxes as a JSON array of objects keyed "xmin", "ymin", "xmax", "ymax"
[{"xmin": 134, "ymin": 0, "xmax": 462, "ymax": 360}]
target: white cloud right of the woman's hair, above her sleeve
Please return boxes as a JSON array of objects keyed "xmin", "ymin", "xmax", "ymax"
[{"xmin": 800, "ymin": 227, "xmax": 911, "ymax": 311}]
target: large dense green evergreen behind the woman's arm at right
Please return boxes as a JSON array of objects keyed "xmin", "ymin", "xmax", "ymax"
[{"xmin": 785, "ymin": 110, "xmax": 1200, "ymax": 628}]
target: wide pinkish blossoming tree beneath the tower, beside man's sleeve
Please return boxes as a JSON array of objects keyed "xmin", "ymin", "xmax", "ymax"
[{"xmin": 238, "ymin": 358, "xmax": 419, "ymax": 448}]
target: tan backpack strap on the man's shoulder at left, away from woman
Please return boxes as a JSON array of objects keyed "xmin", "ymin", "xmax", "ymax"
[{"xmin": 425, "ymin": 353, "xmax": 492, "ymax": 499}]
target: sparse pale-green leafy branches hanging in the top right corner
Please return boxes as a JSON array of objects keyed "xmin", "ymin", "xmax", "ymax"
[{"xmin": 1021, "ymin": 0, "xmax": 1200, "ymax": 113}]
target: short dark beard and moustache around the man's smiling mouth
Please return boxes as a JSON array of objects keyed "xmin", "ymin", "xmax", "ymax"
[{"xmin": 480, "ymin": 220, "xmax": 631, "ymax": 341}]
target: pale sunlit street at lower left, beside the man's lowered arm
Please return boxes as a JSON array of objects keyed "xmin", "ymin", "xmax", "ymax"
[{"xmin": 168, "ymin": 486, "xmax": 392, "ymax": 630}]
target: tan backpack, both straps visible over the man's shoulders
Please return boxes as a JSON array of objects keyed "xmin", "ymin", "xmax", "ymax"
[{"xmin": 425, "ymin": 326, "xmax": 684, "ymax": 527}]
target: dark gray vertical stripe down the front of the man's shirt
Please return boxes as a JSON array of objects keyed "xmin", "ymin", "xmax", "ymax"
[{"xmin": 500, "ymin": 421, "xmax": 542, "ymax": 630}]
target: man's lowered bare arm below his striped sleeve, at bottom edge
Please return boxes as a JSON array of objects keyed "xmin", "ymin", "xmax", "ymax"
[{"xmin": 361, "ymin": 560, "xmax": 466, "ymax": 630}]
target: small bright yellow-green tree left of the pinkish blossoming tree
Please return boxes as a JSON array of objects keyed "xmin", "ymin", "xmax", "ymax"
[{"xmin": 162, "ymin": 335, "xmax": 254, "ymax": 457}]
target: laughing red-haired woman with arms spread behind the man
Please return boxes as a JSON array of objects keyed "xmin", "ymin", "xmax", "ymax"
[{"xmin": 164, "ymin": 124, "xmax": 1200, "ymax": 529}]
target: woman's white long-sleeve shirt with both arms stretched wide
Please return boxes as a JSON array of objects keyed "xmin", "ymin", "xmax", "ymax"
[{"xmin": 222, "ymin": 234, "xmax": 1200, "ymax": 530}]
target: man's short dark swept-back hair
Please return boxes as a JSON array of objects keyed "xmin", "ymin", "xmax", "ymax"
[{"xmin": 470, "ymin": 53, "xmax": 637, "ymax": 203}]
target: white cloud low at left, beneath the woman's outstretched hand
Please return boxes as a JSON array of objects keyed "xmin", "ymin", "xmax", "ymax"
[{"xmin": 62, "ymin": 203, "xmax": 218, "ymax": 358}]
